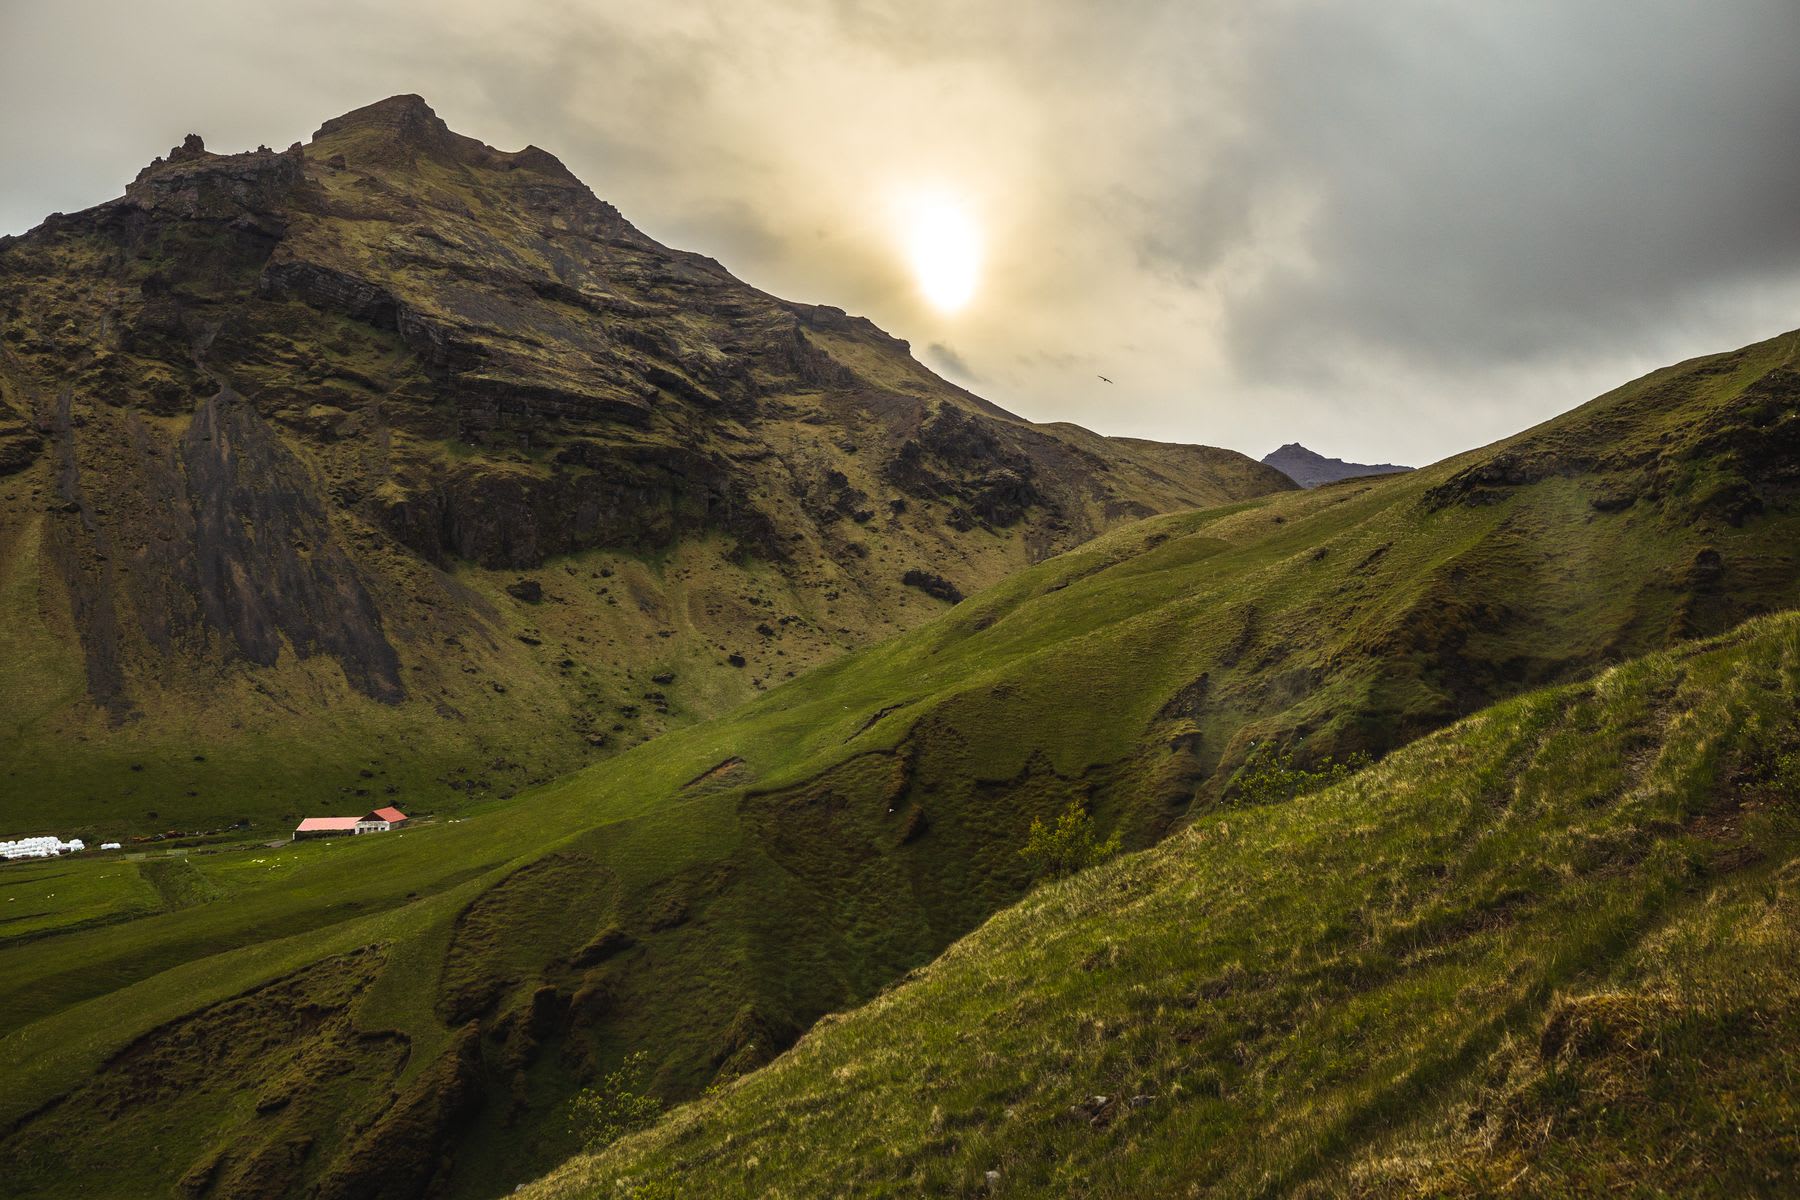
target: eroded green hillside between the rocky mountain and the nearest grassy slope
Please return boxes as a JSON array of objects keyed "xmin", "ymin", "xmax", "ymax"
[{"xmin": 0, "ymin": 336, "xmax": 1800, "ymax": 1196}]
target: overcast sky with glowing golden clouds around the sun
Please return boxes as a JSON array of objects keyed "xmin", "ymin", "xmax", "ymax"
[{"xmin": 0, "ymin": 0, "xmax": 1800, "ymax": 462}]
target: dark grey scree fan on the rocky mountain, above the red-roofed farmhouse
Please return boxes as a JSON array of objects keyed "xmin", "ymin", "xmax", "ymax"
[{"xmin": 36, "ymin": 379, "xmax": 405, "ymax": 718}]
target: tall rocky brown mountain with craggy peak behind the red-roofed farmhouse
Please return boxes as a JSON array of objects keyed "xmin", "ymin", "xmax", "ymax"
[{"xmin": 0, "ymin": 97, "xmax": 1289, "ymax": 828}]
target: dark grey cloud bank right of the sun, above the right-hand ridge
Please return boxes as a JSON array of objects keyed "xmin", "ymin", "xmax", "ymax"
[{"xmin": 1202, "ymin": 2, "xmax": 1800, "ymax": 371}]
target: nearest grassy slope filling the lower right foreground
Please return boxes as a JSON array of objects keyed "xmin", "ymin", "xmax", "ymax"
[{"xmin": 526, "ymin": 615, "xmax": 1800, "ymax": 1200}]
